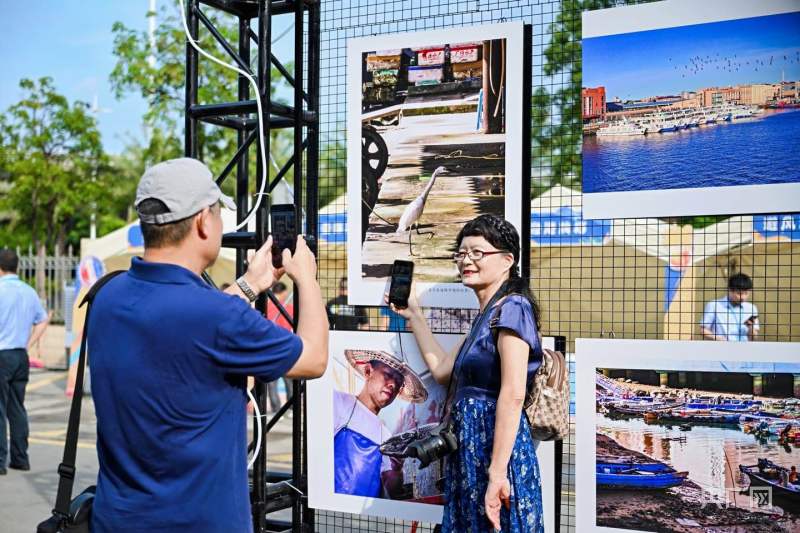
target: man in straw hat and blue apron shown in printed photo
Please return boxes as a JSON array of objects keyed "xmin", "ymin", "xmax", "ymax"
[{"xmin": 333, "ymin": 349, "xmax": 428, "ymax": 498}]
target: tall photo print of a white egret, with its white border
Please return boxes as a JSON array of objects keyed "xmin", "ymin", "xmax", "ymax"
[{"xmin": 347, "ymin": 24, "xmax": 523, "ymax": 307}]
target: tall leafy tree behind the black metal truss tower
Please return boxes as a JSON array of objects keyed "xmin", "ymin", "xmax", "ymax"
[{"xmin": 109, "ymin": 5, "xmax": 330, "ymax": 200}]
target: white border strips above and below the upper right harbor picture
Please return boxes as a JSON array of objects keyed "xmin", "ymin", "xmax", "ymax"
[{"xmin": 582, "ymin": 0, "xmax": 800, "ymax": 220}]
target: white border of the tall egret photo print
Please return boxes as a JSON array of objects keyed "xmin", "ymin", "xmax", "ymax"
[{"xmin": 347, "ymin": 22, "xmax": 530, "ymax": 309}]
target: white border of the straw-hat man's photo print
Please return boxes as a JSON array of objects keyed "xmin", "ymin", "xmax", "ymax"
[{"xmin": 306, "ymin": 331, "xmax": 555, "ymax": 533}]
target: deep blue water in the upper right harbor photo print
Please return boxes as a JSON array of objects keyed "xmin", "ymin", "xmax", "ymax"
[{"xmin": 583, "ymin": 109, "xmax": 800, "ymax": 193}]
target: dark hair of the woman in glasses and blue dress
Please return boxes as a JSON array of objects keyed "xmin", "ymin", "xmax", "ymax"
[{"xmin": 456, "ymin": 215, "xmax": 541, "ymax": 330}]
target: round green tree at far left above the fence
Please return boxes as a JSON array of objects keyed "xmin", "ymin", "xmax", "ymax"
[{"xmin": 0, "ymin": 78, "xmax": 111, "ymax": 253}]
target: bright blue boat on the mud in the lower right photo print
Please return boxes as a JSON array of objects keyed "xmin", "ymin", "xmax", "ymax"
[{"xmin": 595, "ymin": 460, "xmax": 689, "ymax": 490}]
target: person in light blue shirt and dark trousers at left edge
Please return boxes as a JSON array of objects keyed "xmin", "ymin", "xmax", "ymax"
[{"xmin": 0, "ymin": 249, "xmax": 48, "ymax": 475}]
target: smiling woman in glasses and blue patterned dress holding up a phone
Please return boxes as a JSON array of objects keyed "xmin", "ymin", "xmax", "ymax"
[{"xmin": 392, "ymin": 215, "xmax": 544, "ymax": 533}]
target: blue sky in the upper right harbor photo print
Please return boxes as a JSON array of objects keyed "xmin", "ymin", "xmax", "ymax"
[{"xmin": 583, "ymin": 12, "xmax": 800, "ymax": 101}]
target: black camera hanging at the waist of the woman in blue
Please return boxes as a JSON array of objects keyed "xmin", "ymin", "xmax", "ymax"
[{"xmin": 380, "ymin": 421, "xmax": 458, "ymax": 468}]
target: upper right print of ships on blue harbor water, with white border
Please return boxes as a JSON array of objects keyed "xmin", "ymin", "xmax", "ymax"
[{"xmin": 582, "ymin": 0, "xmax": 800, "ymax": 218}]
